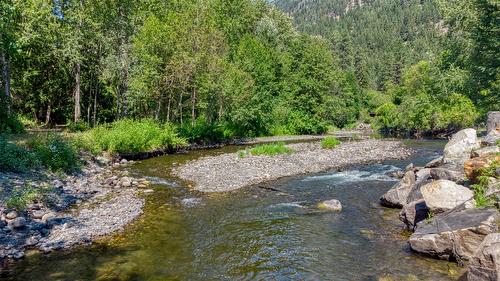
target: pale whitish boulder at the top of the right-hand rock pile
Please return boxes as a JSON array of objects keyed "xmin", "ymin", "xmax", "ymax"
[{"xmin": 443, "ymin": 129, "xmax": 479, "ymax": 164}]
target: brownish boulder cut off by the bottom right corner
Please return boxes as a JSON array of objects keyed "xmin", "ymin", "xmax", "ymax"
[{"xmin": 466, "ymin": 233, "xmax": 500, "ymax": 281}]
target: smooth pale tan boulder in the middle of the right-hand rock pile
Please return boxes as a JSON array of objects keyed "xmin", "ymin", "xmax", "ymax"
[{"xmin": 420, "ymin": 180, "xmax": 474, "ymax": 214}]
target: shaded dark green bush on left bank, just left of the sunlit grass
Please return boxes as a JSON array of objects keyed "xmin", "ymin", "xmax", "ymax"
[{"xmin": 29, "ymin": 135, "xmax": 81, "ymax": 173}]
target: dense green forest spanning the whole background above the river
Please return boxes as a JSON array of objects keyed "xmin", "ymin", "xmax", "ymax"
[{"xmin": 0, "ymin": 0, "xmax": 500, "ymax": 142}]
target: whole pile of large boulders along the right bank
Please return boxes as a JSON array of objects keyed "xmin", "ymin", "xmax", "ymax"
[{"xmin": 381, "ymin": 112, "xmax": 500, "ymax": 280}]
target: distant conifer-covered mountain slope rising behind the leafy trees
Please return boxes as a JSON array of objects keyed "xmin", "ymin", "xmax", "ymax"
[{"xmin": 273, "ymin": 0, "xmax": 446, "ymax": 90}]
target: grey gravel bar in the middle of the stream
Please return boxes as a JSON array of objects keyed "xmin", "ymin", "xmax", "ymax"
[{"xmin": 173, "ymin": 140, "xmax": 412, "ymax": 192}]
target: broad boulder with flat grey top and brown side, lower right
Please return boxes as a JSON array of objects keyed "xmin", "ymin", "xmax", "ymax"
[{"xmin": 410, "ymin": 205, "xmax": 499, "ymax": 261}]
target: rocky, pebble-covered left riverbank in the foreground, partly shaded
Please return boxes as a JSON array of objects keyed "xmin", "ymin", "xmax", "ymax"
[{"xmin": 0, "ymin": 158, "xmax": 149, "ymax": 269}]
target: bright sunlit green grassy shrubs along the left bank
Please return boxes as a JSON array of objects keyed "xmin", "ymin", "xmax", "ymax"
[{"xmin": 73, "ymin": 119, "xmax": 186, "ymax": 154}]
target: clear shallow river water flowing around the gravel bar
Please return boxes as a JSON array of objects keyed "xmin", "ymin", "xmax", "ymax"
[{"xmin": 5, "ymin": 141, "xmax": 460, "ymax": 280}]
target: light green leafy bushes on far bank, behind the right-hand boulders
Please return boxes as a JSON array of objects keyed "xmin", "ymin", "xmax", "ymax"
[{"xmin": 375, "ymin": 61, "xmax": 478, "ymax": 134}]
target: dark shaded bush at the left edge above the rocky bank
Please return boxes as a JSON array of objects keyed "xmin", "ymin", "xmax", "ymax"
[{"xmin": 0, "ymin": 136, "xmax": 39, "ymax": 172}]
